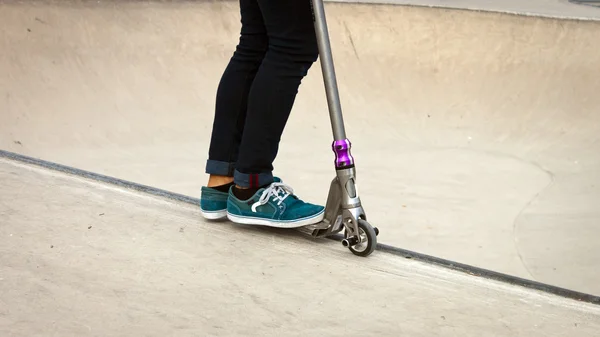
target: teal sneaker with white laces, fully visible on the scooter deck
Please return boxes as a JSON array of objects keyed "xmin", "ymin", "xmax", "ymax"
[{"xmin": 227, "ymin": 181, "xmax": 325, "ymax": 228}]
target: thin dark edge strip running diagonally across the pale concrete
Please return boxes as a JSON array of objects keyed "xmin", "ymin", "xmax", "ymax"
[{"xmin": 0, "ymin": 150, "xmax": 600, "ymax": 305}]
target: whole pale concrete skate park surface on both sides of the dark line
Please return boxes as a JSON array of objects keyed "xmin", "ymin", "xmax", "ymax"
[{"xmin": 0, "ymin": 1, "xmax": 600, "ymax": 336}]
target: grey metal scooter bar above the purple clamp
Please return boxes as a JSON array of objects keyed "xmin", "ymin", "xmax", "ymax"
[{"xmin": 311, "ymin": 0, "xmax": 346, "ymax": 141}]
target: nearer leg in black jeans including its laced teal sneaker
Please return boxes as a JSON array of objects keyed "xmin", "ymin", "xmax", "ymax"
[{"xmin": 228, "ymin": 0, "xmax": 324, "ymax": 227}]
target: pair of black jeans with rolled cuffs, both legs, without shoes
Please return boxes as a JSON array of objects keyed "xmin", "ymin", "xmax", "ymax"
[{"xmin": 206, "ymin": 0, "xmax": 318, "ymax": 187}]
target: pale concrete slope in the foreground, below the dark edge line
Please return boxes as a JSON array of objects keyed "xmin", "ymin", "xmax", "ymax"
[{"xmin": 0, "ymin": 159, "xmax": 600, "ymax": 337}]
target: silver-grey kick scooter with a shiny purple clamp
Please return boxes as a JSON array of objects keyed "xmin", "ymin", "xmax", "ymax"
[{"xmin": 301, "ymin": 0, "xmax": 379, "ymax": 257}]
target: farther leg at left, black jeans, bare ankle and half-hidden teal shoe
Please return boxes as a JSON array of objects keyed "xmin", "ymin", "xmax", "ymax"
[{"xmin": 201, "ymin": 0, "xmax": 268, "ymax": 219}]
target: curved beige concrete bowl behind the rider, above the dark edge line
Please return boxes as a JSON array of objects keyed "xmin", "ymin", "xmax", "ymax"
[{"xmin": 0, "ymin": 1, "xmax": 600, "ymax": 295}]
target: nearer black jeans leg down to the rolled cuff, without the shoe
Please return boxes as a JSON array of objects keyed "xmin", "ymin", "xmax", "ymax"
[{"xmin": 235, "ymin": 0, "xmax": 318, "ymax": 188}]
